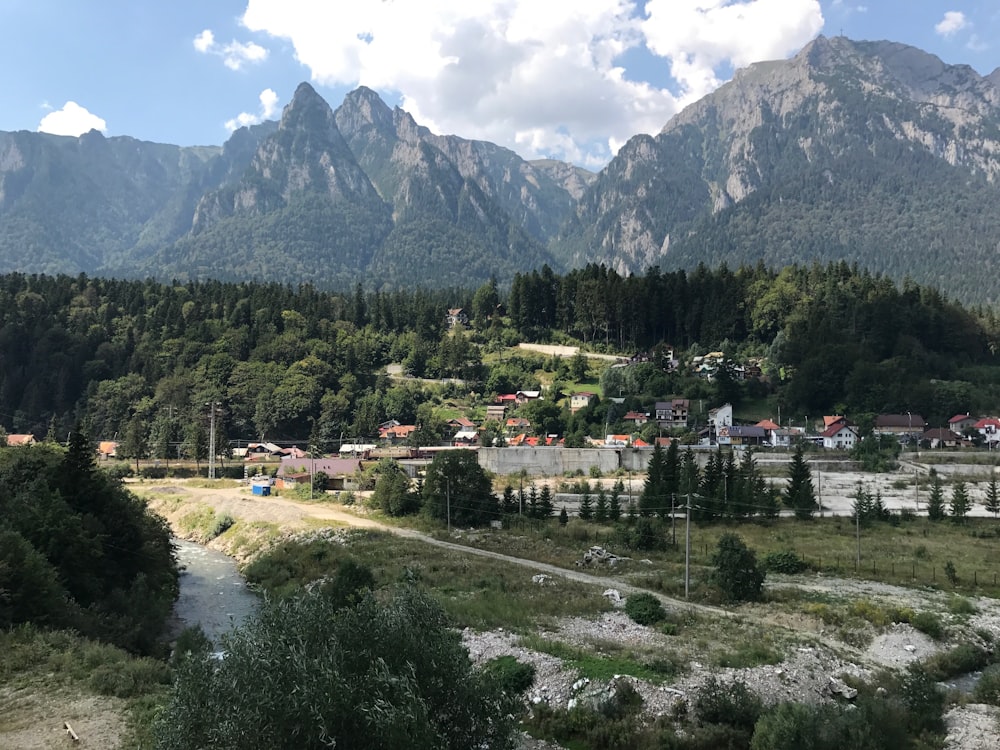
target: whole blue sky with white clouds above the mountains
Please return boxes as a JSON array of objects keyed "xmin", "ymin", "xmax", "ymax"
[{"xmin": 0, "ymin": 0, "xmax": 1000, "ymax": 170}]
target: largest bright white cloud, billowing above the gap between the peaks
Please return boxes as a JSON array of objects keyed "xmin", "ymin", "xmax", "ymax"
[{"xmin": 242, "ymin": 0, "xmax": 823, "ymax": 166}]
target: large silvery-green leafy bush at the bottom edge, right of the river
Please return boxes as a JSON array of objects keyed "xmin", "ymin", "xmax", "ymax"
[{"xmin": 154, "ymin": 588, "xmax": 519, "ymax": 750}]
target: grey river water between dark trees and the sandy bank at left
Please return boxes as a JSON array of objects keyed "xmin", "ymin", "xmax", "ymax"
[{"xmin": 174, "ymin": 539, "xmax": 260, "ymax": 645}]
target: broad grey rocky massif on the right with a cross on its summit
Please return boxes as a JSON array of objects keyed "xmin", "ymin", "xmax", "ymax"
[{"xmin": 552, "ymin": 37, "xmax": 1000, "ymax": 301}]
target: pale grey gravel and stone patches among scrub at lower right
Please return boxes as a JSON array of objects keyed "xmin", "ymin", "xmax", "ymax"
[{"xmin": 462, "ymin": 579, "xmax": 1000, "ymax": 750}]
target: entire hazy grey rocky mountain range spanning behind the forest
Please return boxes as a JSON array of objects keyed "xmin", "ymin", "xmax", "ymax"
[{"xmin": 0, "ymin": 37, "xmax": 1000, "ymax": 304}]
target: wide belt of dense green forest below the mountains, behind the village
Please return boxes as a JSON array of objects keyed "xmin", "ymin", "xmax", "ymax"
[{"xmin": 0, "ymin": 264, "xmax": 1000, "ymax": 458}]
